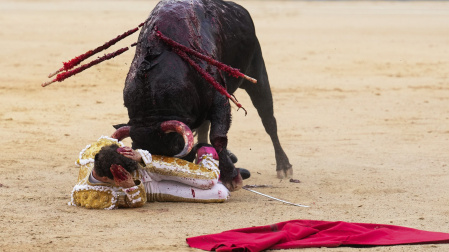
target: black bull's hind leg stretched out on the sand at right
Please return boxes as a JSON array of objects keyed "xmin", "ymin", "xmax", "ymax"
[{"xmin": 241, "ymin": 41, "xmax": 293, "ymax": 178}]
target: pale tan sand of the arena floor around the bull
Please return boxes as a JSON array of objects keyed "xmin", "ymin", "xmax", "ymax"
[{"xmin": 0, "ymin": 0, "xmax": 449, "ymax": 252}]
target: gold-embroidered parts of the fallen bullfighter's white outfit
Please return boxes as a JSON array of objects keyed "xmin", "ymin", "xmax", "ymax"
[{"xmin": 69, "ymin": 136, "xmax": 221, "ymax": 209}]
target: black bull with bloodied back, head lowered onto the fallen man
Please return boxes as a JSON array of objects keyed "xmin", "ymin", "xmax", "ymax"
[{"xmin": 114, "ymin": 0, "xmax": 292, "ymax": 190}]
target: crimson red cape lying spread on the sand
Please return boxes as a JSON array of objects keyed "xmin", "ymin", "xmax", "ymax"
[{"xmin": 186, "ymin": 220, "xmax": 449, "ymax": 252}]
